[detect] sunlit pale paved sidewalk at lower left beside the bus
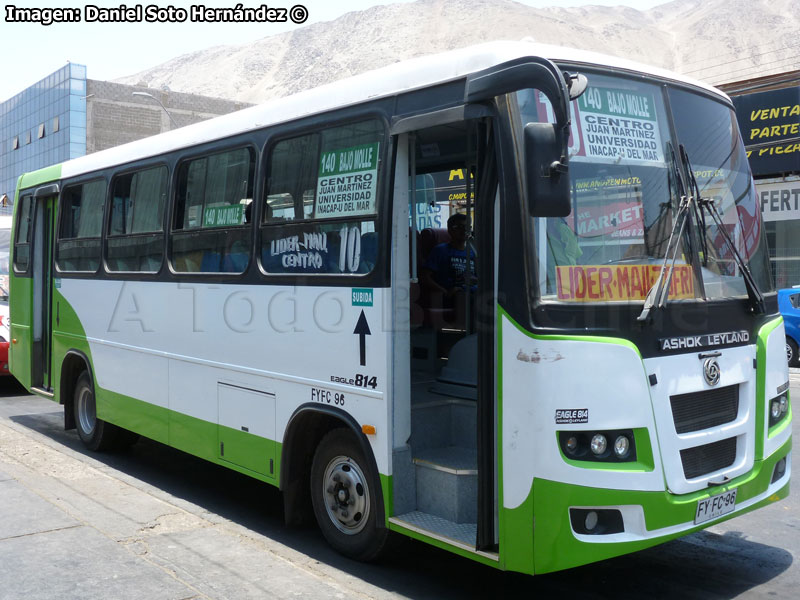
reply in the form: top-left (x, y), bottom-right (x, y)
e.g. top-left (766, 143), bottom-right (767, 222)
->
top-left (0, 397), bottom-right (396, 600)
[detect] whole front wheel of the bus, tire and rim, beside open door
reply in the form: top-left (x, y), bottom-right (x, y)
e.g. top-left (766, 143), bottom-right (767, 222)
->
top-left (311, 429), bottom-right (389, 561)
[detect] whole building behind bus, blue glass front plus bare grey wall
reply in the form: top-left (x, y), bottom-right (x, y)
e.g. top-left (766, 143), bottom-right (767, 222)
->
top-left (0, 63), bottom-right (250, 214)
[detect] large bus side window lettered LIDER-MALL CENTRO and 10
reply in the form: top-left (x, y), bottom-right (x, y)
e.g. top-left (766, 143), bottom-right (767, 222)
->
top-left (261, 121), bottom-right (384, 275)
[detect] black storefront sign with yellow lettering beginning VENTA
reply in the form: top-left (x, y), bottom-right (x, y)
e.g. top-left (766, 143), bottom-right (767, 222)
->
top-left (733, 87), bottom-right (800, 176)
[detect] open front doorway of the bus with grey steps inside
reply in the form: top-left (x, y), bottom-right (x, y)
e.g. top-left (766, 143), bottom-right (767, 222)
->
top-left (390, 113), bottom-right (498, 556)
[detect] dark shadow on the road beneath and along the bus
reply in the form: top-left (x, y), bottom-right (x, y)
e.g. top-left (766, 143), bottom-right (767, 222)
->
top-left (6, 411), bottom-right (793, 600)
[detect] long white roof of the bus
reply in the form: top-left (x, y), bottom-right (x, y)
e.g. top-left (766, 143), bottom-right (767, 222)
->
top-left (45, 42), bottom-right (727, 183)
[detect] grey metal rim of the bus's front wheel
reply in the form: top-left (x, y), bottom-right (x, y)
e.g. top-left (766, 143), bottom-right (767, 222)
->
top-left (322, 456), bottom-right (369, 535)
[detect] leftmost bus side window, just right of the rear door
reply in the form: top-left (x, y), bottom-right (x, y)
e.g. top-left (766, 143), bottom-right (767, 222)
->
top-left (56, 181), bottom-right (106, 272)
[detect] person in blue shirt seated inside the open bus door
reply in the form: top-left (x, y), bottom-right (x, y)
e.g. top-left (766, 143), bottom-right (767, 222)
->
top-left (420, 213), bottom-right (477, 298)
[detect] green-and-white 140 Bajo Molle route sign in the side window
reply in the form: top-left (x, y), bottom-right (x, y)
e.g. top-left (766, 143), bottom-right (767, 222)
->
top-left (315, 142), bottom-right (380, 218)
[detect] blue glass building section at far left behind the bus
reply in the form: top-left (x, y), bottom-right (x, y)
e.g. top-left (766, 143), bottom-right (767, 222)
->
top-left (0, 63), bottom-right (86, 214)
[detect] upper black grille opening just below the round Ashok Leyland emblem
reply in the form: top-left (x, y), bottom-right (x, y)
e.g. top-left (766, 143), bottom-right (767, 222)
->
top-left (669, 385), bottom-right (739, 433)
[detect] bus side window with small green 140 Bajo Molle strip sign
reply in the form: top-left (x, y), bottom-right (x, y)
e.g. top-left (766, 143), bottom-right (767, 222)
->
top-left (170, 148), bottom-right (255, 273)
